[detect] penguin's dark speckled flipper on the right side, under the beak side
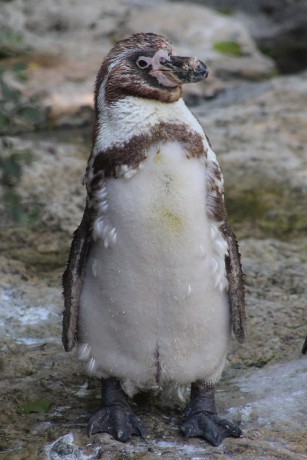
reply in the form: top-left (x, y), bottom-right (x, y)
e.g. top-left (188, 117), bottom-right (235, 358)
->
top-left (221, 220), bottom-right (246, 343)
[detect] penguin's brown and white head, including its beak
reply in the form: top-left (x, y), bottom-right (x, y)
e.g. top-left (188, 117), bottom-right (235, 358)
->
top-left (95, 33), bottom-right (208, 111)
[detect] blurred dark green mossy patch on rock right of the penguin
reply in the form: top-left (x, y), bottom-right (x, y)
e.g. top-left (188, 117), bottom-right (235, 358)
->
top-left (225, 183), bottom-right (307, 240)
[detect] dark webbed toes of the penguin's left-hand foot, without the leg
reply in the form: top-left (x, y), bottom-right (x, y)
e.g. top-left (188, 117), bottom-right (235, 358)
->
top-left (87, 404), bottom-right (144, 442)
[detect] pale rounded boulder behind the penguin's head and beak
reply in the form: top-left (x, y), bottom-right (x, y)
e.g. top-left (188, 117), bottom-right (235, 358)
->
top-left (127, 3), bottom-right (274, 80)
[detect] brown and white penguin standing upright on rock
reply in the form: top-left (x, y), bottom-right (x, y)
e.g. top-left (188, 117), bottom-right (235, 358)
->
top-left (63, 33), bottom-right (246, 446)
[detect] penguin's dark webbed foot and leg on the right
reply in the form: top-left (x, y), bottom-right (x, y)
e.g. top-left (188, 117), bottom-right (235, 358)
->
top-left (181, 380), bottom-right (242, 446)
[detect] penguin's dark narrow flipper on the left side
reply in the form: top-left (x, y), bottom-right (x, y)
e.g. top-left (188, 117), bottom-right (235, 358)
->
top-left (62, 206), bottom-right (91, 351)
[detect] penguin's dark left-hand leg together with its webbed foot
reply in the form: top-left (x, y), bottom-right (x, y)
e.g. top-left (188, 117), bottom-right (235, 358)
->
top-left (87, 378), bottom-right (144, 442)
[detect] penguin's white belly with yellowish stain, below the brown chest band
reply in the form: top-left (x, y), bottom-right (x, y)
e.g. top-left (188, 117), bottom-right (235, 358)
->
top-left (79, 142), bottom-right (230, 393)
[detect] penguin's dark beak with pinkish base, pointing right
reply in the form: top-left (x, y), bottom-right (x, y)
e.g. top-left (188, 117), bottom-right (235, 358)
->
top-left (159, 56), bottom-right (209, 85)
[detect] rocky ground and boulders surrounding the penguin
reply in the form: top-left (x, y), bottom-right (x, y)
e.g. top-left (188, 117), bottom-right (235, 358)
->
top-left (0, 0), bottom-right (307, 460)
